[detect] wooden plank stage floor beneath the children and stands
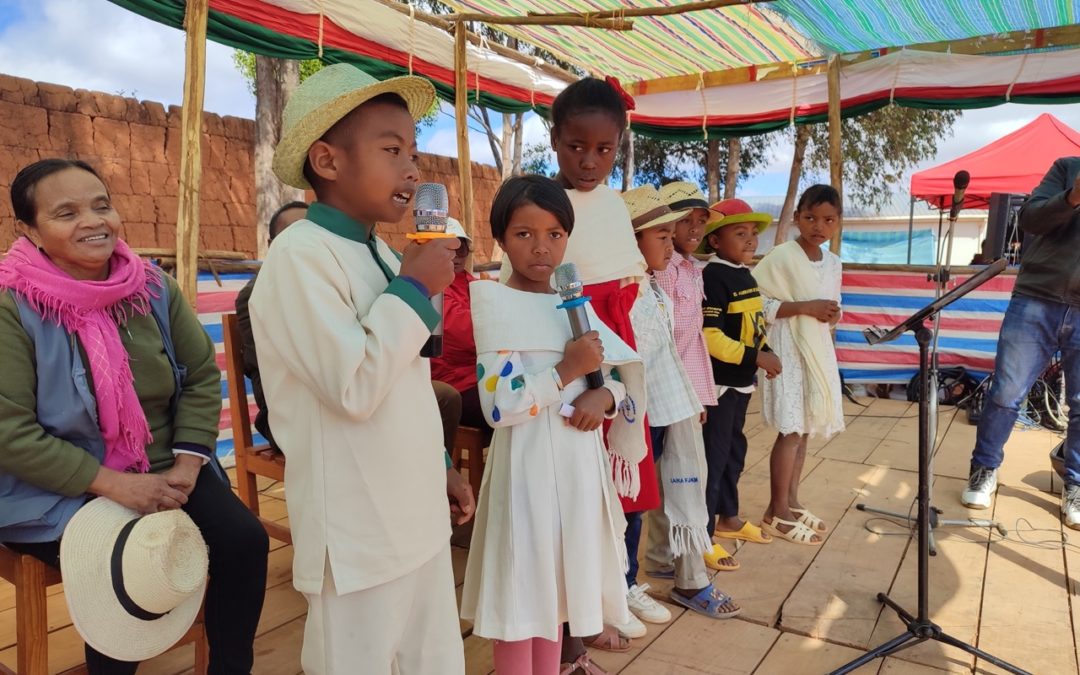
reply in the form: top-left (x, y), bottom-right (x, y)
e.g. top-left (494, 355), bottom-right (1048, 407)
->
top-left (0, 399), bottom-right (1067, 675)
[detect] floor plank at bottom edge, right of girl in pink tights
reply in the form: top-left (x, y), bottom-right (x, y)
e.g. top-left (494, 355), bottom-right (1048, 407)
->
top-left (617, 611), bottom-right (780, 675)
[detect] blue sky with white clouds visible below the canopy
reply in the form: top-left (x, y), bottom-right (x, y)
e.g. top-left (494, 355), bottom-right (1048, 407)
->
top-left (0, 0), bottom-right (1080, 197)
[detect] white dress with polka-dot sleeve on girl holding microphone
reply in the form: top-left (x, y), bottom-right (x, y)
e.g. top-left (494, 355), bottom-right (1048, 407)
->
top-left (461, 282), bottom-right (629, 640)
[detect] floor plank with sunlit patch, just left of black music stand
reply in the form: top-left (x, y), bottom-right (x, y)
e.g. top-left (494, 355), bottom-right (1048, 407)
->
top-left (781, 468), bottom-right (914, 648)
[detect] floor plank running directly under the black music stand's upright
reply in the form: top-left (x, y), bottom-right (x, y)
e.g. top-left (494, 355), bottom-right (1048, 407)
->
top-left (869, 478), bottom-right (989, 672)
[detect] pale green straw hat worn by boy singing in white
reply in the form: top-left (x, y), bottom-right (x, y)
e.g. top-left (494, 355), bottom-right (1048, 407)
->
top-left (273, 64), bottom-right (435, 190)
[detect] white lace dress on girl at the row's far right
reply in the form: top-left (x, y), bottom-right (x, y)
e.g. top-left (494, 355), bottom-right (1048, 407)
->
top-left (758, 251), bottom-right (843, 437)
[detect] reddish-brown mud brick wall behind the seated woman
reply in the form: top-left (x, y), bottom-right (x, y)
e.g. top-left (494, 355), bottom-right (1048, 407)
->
top-left (0, 75), bottom-right (500, 261)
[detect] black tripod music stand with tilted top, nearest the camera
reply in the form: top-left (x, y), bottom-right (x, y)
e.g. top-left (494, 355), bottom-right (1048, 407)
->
top-left (832, 259), bottom-right (1030, 675)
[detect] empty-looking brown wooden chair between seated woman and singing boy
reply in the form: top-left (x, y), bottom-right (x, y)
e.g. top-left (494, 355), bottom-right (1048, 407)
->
top-left (221, 313), bottom-right (293, 543)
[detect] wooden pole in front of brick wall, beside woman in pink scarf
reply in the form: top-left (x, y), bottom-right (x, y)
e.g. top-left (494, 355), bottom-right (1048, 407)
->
top-left (176, 0), bottom-right (210, 308)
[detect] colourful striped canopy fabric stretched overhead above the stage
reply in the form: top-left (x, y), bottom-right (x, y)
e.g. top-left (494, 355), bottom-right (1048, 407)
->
top-left (111, 0), bottom-right (1080, 140)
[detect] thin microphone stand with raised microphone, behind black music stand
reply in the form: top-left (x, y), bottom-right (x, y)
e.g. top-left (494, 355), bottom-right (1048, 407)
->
top-left (855, 193), bottom-right (1008, 555)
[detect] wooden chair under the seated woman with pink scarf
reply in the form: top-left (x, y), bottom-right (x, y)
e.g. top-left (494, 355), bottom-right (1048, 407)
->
top-left (0, 545), bottom-right (210, 675)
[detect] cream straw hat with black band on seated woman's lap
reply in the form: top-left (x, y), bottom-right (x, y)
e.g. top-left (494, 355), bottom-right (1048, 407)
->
top-left (60, 497), bottom-right (208, 661)
